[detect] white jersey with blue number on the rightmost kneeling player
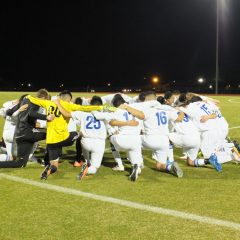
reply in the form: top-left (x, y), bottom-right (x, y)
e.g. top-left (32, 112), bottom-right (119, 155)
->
top-left (180, 101), bottom-right (217, 132)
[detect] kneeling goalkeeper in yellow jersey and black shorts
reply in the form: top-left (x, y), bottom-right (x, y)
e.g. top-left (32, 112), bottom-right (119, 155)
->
top-left (27, 91), bottom-right (103, 180)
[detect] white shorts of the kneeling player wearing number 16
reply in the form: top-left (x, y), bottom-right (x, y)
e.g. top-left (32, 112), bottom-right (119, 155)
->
top-left (142, 135), bottom-right (169, 164)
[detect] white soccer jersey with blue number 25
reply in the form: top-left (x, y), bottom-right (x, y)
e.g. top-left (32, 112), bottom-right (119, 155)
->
top-left (71, 111), bottom-right (107, 139)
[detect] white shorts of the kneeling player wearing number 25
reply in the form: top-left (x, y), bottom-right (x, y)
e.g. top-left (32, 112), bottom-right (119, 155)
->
top-left (81, 137), bottom-right (105, 168)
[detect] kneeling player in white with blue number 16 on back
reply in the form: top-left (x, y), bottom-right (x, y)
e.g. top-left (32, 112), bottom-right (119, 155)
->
top-left (119, 100), bottom-right (183, 177)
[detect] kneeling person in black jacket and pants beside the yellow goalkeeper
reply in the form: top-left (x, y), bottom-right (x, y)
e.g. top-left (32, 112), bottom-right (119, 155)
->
top-left (0, 89), bottom-right (54, 168)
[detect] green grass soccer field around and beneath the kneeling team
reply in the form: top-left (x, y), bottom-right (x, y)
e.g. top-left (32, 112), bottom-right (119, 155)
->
top-left (0, 92), bottom-right (240, 240)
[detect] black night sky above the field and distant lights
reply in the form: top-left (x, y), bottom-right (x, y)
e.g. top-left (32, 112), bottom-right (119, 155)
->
top-left (0, 0), bottom-right (240, 90)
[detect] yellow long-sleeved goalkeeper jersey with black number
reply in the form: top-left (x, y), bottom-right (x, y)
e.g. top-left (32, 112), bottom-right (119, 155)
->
top-left (27, 95), bottom-right (103, 144)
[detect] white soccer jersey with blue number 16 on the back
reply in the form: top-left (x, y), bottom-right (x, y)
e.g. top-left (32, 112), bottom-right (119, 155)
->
top-left (143, 108), bottom-right (178, 135)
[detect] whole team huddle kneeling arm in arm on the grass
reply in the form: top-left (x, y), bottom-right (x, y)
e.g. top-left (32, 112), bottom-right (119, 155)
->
top-left (0, 89), bottom-right (240, 181)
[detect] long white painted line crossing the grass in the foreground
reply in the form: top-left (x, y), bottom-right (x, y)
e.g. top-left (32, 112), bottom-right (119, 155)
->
top-left (0, 173), bottom-right (240, 231)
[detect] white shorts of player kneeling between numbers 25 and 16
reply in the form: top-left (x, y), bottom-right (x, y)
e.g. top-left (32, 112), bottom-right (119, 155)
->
top-left (110, 134), bottom-right (143, 165)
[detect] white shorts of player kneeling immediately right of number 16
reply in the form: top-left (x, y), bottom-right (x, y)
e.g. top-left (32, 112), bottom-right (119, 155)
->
top-left (169, 132), bottom-right (201, 160)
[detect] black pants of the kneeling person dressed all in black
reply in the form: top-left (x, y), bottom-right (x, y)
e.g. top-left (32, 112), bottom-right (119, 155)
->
top-left (0, 132), bottom-right (46, 168)
